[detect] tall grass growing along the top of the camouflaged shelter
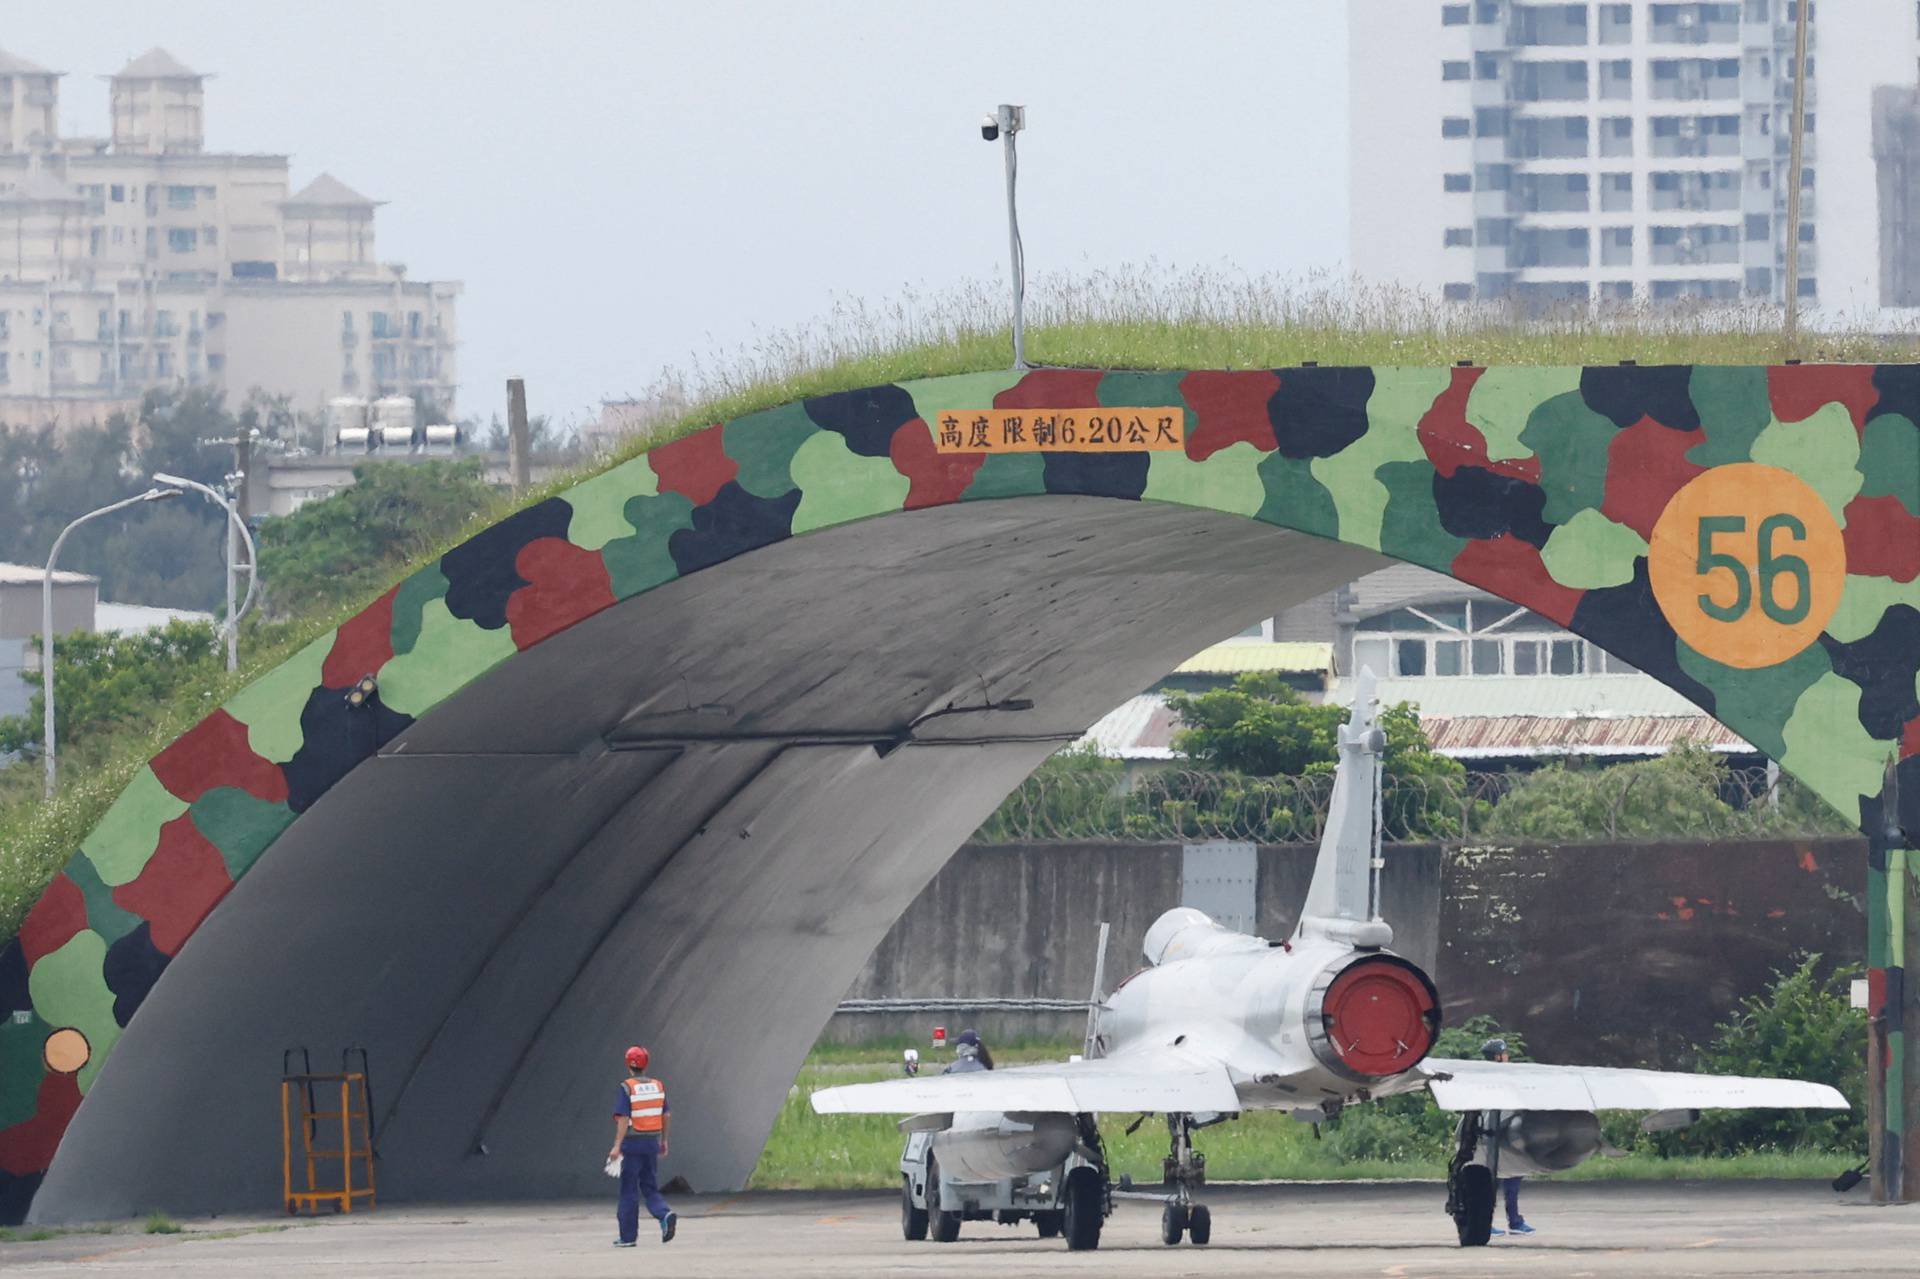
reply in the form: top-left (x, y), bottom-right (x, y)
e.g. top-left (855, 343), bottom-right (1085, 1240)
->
top-left (0, 263), bottom-right (1920, 939)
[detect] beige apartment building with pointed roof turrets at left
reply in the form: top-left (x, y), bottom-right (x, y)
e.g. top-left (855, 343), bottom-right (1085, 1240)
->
top-left (0, 50), bottom-right (461, 424)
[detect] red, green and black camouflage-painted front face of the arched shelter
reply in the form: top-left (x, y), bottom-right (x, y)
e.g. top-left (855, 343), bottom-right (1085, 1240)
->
top-left (0, 365), bottom-right (1920, 1214)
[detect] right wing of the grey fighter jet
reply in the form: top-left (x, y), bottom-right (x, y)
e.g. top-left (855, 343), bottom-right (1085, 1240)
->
top-left (1421, 1056), bottom-right (1847, 1110)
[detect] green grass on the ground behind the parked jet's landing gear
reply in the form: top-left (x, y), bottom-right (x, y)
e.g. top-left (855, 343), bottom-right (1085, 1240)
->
top-left (749, 1043), bottom-right (1859, 1191)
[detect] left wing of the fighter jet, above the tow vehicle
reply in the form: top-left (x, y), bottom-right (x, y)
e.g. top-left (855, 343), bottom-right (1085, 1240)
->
top-left (812, 1050), bottom-right (1240, 1114)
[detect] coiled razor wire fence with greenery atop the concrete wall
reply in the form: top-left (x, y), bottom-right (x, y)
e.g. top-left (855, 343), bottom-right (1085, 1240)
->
top-left (973, 753), bottom-right (1859, 843)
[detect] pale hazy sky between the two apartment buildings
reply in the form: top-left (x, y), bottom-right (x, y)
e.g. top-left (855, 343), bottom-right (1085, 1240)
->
top-left (22, 0), bottom-right (1346, 428)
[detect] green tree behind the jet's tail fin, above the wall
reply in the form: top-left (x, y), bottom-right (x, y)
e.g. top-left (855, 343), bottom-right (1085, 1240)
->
top-left (1167, 674), bottom-right (1467, 839)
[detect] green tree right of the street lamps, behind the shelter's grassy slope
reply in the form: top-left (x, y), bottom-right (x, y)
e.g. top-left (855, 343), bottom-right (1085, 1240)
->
top-left (257, 459), bottom-right (493, 616)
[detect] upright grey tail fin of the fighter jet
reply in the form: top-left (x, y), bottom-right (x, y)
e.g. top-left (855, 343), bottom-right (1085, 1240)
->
top-left (1296, 668), bottom-right (1394, 947)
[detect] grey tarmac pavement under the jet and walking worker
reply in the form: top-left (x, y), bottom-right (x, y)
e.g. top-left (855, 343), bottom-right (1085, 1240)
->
top-left (0, 1181), bottom-right (1920, 1279)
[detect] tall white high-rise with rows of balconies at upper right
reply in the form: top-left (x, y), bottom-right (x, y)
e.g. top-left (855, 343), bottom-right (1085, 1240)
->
top-left (1348, 0), bottom-right (1920, 311)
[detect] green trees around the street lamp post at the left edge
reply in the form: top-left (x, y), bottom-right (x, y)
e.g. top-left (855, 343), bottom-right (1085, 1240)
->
top-left (0, 622), bottom-right (225, 759)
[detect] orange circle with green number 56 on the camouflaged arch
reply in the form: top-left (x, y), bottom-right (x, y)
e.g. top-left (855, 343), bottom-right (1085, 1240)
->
top-left (1647, 463), bottom-right (1847, 670)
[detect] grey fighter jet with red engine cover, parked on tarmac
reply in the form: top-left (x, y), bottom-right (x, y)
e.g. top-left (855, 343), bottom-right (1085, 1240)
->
top-left (812, 672), bottom-right (1847, 1248)
